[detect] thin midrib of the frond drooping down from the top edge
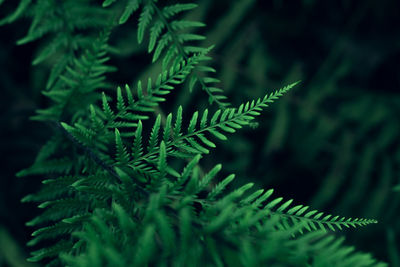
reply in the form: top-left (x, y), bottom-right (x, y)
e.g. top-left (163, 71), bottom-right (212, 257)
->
top-left (150, 1), bottom-right (226, 109)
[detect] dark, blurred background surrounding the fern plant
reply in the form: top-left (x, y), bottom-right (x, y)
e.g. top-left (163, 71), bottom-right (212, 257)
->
top-left (0, 0), bottom-right (400, 266)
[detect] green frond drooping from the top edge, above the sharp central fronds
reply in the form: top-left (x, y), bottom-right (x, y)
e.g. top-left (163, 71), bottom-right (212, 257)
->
top-left (103, 0), bottom-right (229, 108)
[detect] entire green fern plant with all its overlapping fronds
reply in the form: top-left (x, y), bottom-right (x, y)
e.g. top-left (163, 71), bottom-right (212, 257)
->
top-left (0, 0), bottom-right (384, 266)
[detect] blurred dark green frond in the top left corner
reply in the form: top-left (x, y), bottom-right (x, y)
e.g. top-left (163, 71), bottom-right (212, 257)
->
top-left (0, 0), bottom-right (111, 90)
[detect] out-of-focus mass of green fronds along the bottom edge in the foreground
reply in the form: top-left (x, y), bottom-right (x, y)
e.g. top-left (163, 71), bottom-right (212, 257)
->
top-left (57, 172), bottom-right (386, 267)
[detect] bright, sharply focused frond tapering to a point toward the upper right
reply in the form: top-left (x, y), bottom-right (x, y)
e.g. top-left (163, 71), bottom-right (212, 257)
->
top-left (129, 83), bottom-right (297, 171)
